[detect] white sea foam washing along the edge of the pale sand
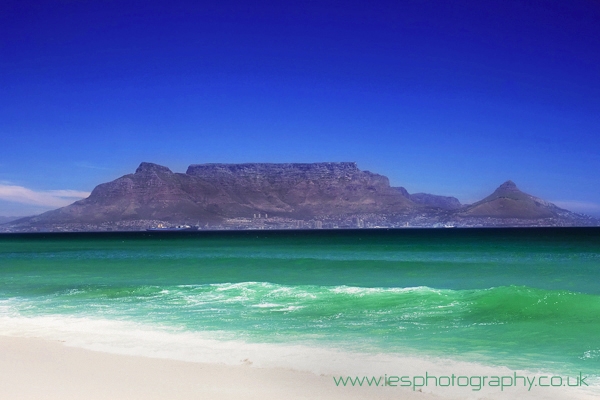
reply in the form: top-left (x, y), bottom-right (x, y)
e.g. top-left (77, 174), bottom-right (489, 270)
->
top-left (0, 314), bottom-right (600, 399)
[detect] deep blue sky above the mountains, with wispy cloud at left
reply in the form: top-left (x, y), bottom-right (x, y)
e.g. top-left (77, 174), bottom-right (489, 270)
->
top-left (0, 0), bottom-right (600, 215)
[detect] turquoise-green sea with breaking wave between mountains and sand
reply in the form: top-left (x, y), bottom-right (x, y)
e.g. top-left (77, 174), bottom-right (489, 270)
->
top-left (0, 228), bottom-right (600, 375)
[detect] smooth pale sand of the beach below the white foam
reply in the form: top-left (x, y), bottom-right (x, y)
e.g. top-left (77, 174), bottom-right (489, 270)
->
top-left (0, 336), bottom-right (597, 400)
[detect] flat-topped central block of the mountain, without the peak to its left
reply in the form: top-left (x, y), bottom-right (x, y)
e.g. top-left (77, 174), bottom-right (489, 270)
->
top-left (186, 163), bottom-right (414, 218)
